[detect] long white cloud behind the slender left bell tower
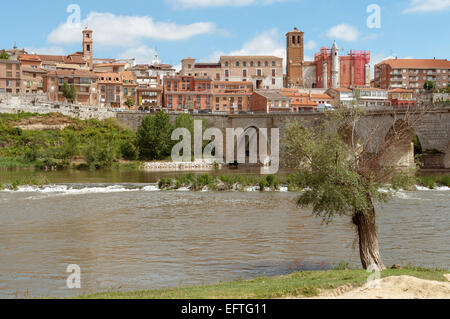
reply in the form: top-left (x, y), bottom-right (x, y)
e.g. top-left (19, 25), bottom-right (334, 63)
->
top-left (48, 12), bottom-right (217, 47)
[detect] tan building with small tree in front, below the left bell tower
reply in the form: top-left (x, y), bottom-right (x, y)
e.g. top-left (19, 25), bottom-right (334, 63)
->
top-left (43, 70), bottom-right (98, 105)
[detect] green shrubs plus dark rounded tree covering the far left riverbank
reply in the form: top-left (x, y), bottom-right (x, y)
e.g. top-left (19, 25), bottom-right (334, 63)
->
top-left (0, 112), bottom-right (206, 171)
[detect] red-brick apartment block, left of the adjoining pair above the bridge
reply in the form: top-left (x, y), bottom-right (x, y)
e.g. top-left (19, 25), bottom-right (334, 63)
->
top-left (163, 76), bottom-right (213, 111)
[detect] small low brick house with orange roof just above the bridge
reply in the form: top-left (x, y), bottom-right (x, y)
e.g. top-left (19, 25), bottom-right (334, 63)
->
top-left (250, 90), bottom-right (291, 113)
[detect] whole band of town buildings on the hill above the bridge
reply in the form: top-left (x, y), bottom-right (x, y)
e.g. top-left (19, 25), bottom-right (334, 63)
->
top-left (0, 28), bottom-right (450, 114)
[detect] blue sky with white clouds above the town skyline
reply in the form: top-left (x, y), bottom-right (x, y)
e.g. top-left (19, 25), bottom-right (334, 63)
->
top-left (0, 0), bottom-right (450, 77)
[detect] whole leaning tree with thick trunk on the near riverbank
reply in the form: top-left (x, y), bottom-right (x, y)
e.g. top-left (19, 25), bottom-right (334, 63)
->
top-left (284, 109), bottom-right (426, 270)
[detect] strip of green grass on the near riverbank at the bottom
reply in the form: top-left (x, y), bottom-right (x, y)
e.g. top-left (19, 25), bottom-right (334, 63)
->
top-left (79, 267), bottom-right (449, 299)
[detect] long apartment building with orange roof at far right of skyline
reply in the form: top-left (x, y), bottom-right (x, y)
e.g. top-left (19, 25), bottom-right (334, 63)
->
top-left (374, 59), bottom-right (450, 94)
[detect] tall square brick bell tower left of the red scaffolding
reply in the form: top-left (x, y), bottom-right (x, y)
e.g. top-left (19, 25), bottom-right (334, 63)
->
top-left (286, 28), bottom-right (304, 88)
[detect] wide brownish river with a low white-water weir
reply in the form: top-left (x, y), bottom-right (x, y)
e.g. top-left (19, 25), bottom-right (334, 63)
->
top-left (0, 171), bottom-right (450, 298)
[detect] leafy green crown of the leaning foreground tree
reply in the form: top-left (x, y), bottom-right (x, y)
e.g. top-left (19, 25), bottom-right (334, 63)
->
top-left (285, 122), bottom-right (372, 221)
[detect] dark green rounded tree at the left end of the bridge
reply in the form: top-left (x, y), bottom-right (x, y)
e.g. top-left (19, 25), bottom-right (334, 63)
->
top-left (136, 111), bottom-right (174, 160)
